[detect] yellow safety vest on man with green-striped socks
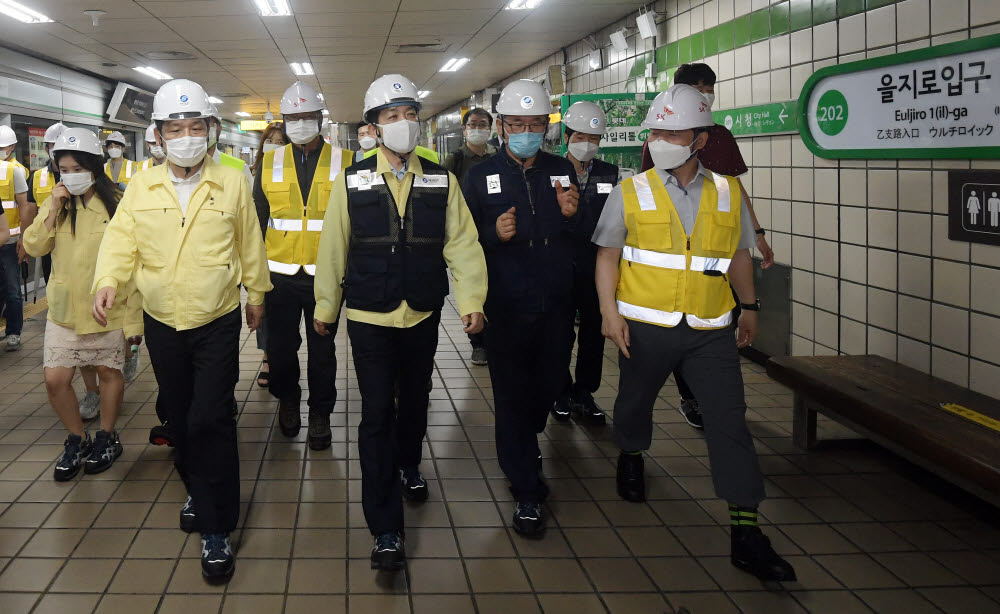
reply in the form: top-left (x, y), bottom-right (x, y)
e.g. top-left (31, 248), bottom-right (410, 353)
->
top-left (617, 169), bottom-right (742, 329)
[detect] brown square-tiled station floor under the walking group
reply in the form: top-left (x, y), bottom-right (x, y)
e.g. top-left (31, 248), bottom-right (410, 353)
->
top-left (0, 296), bottom-right (1000, 614)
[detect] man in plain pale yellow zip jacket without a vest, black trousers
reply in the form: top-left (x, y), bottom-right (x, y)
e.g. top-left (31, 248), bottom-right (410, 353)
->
top-left (94, 79), bottom-right (271, 579)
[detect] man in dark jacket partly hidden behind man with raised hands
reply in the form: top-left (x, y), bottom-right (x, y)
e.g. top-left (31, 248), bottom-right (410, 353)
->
top-left (552, 101), bottom-right (618, 426)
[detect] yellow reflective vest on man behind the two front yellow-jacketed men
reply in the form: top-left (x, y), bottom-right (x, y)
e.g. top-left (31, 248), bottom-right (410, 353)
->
top-left (260, 143), bottom-right (354, 275)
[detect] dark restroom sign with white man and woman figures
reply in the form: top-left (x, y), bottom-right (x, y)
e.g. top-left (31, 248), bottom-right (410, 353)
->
top-left (948, 170), bottom-right (1000, 245)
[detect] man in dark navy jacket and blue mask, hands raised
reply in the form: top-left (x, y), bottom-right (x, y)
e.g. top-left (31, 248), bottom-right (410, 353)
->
top-left (463, 80), bottom-right (579, 536)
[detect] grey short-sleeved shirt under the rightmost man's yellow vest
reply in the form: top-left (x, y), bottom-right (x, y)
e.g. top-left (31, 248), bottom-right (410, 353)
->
top-left (592, 164), bottom-right (757, 249)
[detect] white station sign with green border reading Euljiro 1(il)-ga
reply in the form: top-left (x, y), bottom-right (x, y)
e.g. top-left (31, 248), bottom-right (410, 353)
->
top-left (798, 34), bottom-right (1000, 159)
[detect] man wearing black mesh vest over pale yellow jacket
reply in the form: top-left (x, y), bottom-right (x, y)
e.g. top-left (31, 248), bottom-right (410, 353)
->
top-left (314, 75), bottom-right (486, 570)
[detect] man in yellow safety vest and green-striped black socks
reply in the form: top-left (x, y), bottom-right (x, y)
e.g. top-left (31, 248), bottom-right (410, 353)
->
top-left (593, 84), bottom-right (795, 582)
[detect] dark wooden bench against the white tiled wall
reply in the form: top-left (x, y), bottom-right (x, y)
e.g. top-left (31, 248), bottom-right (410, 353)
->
top-left (767, 356), bottom-right (1000, 506)
